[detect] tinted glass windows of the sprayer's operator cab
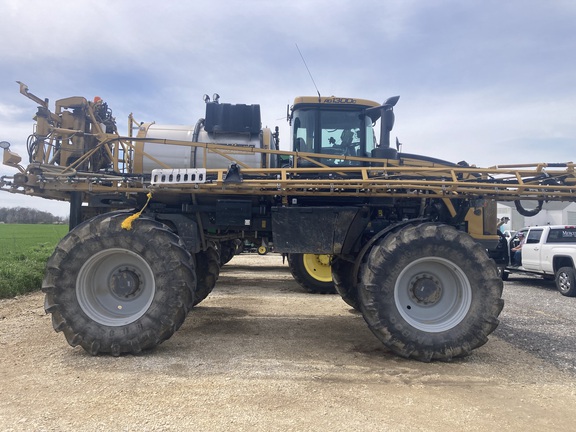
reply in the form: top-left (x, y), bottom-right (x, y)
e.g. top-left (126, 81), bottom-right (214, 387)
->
top-left (292, 108), bottom-right (375, 165)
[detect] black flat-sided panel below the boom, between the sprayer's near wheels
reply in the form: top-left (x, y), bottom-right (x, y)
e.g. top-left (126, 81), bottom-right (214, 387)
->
top-left (272, 207), bottom-right (360, 254)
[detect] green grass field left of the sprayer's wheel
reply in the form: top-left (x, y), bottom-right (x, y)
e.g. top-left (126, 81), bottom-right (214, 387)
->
top-left (0, 224), bottom-right (68, 298)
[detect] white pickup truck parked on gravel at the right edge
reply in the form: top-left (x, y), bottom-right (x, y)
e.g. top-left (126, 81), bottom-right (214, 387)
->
top-left (502, 225), bottom-right (576, 297)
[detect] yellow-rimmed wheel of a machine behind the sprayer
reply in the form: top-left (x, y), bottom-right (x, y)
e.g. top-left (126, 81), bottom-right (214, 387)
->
top-left (288, 254), bottom-right (336, 294)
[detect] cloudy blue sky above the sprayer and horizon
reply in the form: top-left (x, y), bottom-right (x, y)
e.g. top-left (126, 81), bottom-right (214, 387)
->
top-left (0, 0), bottom-right (576, 215)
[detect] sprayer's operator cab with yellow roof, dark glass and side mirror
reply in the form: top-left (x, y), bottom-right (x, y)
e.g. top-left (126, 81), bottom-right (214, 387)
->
top-left (288, 96), bottom-right (399, 166)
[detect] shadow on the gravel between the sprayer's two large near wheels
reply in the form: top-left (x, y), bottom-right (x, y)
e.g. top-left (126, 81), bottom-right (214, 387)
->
top-left (164, 300), bottom-right (397, 370)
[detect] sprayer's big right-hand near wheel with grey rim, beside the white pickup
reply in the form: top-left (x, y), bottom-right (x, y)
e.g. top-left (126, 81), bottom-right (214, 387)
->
top-left (358, 223), bottom-right (504, 361)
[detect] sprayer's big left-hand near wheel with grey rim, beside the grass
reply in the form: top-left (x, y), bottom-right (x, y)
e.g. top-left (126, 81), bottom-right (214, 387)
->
top-left (42, 214), bottom-right (196, 356)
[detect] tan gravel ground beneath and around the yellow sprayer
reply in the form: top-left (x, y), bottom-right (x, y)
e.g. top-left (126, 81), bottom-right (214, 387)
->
top-left (0, 255), bottom-right (576, 431)
